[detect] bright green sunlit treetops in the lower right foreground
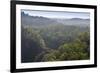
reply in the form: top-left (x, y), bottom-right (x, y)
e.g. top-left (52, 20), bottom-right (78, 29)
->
top-left (44, 32), bottom-right (89, 61)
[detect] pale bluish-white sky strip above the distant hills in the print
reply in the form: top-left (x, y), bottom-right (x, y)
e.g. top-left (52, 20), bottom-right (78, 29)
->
top-left (21, 9), bottom-right (90, 19)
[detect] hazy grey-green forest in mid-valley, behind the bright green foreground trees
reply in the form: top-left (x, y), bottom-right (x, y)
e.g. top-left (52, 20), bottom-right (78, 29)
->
top-left (40, 25), bottom-right (89, 49)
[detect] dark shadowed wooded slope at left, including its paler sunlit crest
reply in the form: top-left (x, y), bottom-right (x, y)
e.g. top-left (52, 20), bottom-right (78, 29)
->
top-left (21, 26), bottom-right (48, 62)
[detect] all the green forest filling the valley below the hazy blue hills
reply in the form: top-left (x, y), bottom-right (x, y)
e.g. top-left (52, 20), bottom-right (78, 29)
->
top-left (21, 12), bottom-right (90, 62)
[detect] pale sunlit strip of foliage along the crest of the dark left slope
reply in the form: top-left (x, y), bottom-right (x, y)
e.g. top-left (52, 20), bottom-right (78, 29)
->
top-left (25, 27), bottom-right (47, 49)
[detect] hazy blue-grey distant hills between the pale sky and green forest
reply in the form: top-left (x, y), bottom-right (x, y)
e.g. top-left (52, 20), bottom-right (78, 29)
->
top-left (21, 12), bottom-right (90, 27)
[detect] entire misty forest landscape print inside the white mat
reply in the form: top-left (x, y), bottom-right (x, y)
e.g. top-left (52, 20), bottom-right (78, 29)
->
top-left (21, 10), bottom-right (90, 63)
